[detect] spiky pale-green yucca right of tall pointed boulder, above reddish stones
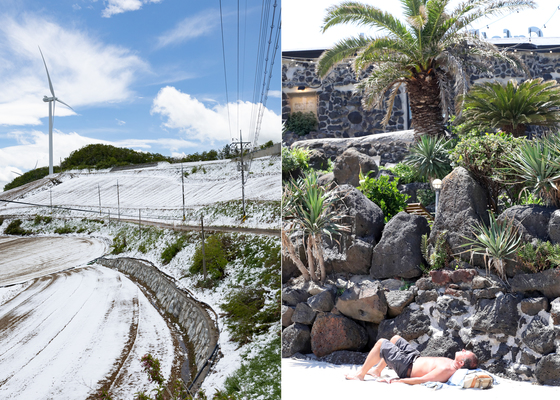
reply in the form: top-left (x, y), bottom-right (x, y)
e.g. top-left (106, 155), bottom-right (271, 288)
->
top-left (462, 213), bottom-right (521, 280)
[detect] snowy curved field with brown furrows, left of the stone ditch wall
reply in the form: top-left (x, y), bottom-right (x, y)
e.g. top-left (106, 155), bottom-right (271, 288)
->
top-left (0, 238), bottom-right (179, 399)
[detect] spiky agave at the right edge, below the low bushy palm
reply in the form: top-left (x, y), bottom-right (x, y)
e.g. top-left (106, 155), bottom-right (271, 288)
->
top-left (500, 135), bottom-right (560, 206)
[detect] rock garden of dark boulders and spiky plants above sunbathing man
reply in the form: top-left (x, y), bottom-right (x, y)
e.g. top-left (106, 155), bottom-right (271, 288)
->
top-left (282, 127), bottom-right (560, 386)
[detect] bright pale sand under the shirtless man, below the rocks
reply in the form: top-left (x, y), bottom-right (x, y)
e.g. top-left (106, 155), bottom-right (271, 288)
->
top-left (282, 358), bottom-right (560, 400)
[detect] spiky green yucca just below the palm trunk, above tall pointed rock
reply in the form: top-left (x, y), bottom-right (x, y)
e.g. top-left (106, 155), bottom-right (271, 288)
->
top-left (404, 135), bottom-right (451, 182)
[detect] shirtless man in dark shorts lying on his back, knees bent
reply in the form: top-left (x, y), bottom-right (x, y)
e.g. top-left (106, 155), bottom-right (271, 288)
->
top-left (346, 335), bottom-right (478, 385)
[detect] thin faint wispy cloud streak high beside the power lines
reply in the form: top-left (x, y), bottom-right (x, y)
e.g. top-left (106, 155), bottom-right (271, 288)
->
top-left (157, 10), bottom-right (219, 48)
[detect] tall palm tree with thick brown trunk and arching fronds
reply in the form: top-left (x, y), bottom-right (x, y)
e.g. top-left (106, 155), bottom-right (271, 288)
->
top-left (317, 0), bottom-right (535, 137)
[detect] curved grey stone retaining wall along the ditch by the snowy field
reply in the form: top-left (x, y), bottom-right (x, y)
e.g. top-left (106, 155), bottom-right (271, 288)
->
top-left (97, 258), bottom-right (219, 379)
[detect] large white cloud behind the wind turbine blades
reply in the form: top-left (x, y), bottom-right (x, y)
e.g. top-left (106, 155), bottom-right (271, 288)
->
top-left (0, 15), bottom-right (147, 125)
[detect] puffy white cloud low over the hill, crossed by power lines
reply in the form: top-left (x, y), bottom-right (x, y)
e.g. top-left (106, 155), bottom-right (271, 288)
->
top-left (151, 86), bottom-right (281, 143)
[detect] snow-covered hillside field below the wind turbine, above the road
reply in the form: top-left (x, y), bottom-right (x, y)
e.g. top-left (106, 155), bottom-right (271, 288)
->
top-left (0, 157), bottom-right (282, 229)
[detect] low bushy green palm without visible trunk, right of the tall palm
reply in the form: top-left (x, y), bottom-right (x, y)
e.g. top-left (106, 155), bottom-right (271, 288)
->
top-left (462, 78), bottom-right (560, 137)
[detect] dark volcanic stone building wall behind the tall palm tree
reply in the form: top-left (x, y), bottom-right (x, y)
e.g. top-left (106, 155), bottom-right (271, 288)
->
top-left (282, 51), bottom-right (560, 145)
